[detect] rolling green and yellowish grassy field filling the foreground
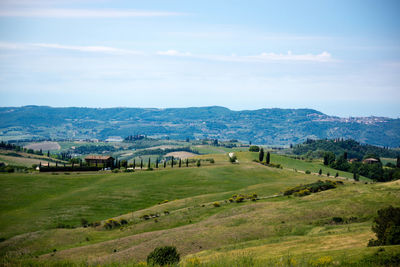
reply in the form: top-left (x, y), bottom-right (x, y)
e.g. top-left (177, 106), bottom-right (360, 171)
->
top-left (0, 152), bottom-right (400, 266)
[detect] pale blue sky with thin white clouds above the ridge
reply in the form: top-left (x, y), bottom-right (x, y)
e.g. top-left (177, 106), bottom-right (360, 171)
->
top-left (0, 0), bottom-right (400, 118)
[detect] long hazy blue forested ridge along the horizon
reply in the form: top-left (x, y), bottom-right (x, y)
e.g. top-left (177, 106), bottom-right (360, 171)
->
top-left (0, 106), bottom-right (400, 147)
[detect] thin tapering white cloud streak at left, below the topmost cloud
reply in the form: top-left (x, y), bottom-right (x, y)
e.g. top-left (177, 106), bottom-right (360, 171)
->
top-left (32, 43), bottom-right (142, 55)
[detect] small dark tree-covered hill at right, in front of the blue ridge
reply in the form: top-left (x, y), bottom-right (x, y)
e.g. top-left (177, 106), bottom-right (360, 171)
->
top-left (293, 139), bottom-right (400, 159)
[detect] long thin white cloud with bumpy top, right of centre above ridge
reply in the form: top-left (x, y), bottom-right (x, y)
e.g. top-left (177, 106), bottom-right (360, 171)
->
top-left (157, 50), bottom-right (334, 62)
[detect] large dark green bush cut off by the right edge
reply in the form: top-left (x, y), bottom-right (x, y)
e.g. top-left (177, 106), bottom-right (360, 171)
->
top-left (368, 206), bottom-right (400, 246)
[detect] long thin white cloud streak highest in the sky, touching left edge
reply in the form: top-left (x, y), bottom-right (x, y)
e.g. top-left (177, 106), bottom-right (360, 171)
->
top-left (0, 8), bottom-right (182, 18)
